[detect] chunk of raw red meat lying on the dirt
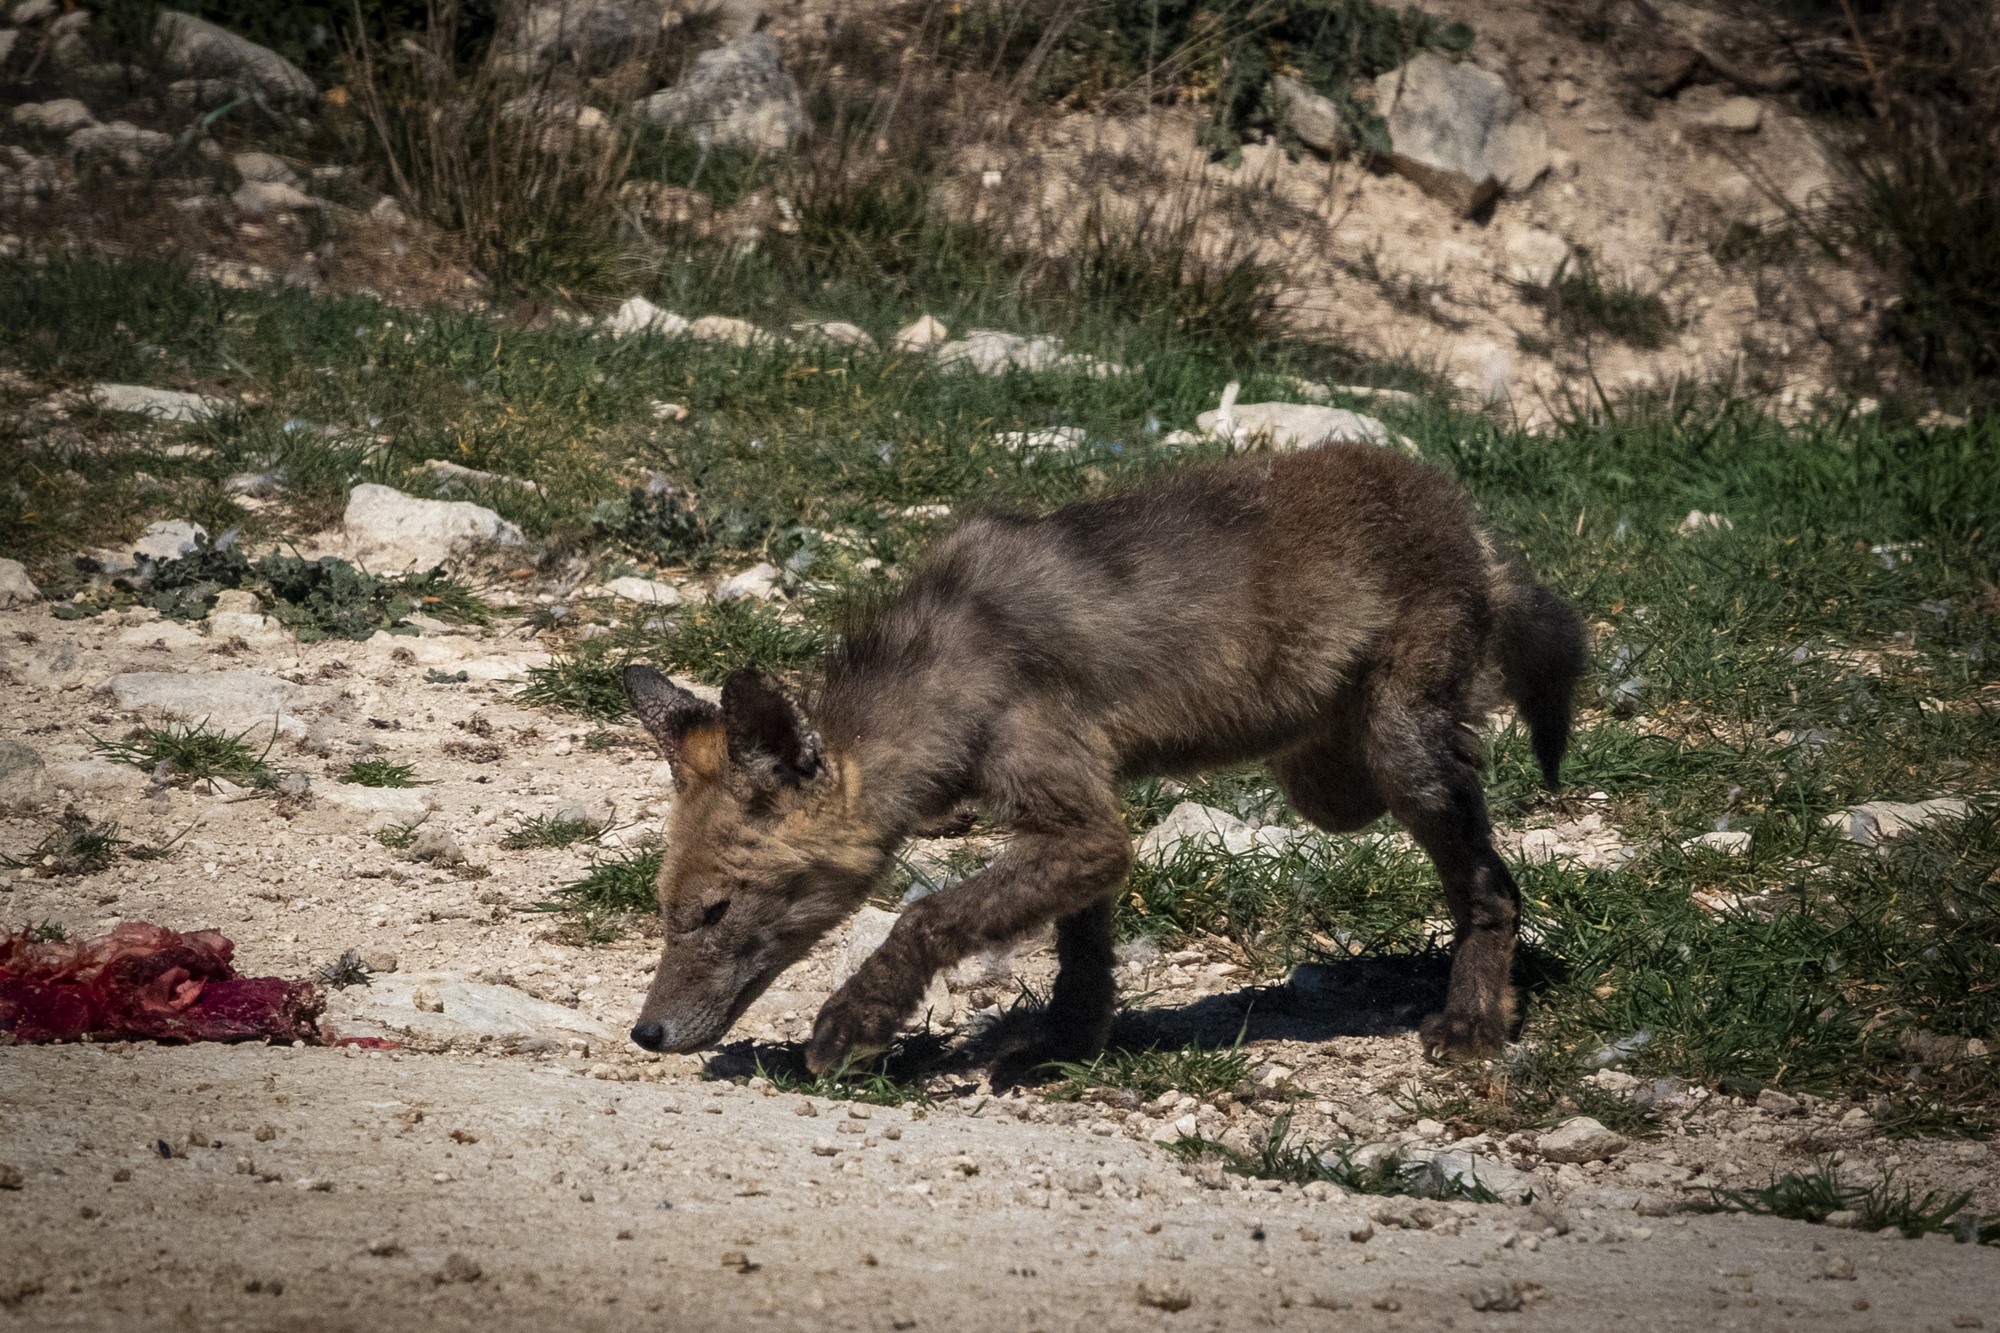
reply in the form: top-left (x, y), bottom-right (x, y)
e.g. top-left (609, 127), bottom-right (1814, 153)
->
top-left (0, 921), bottom-right (324, 1045)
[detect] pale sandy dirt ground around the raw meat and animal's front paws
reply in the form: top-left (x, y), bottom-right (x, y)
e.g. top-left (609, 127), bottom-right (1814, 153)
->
top-left (0, 608), bottom-right (2000, 1329)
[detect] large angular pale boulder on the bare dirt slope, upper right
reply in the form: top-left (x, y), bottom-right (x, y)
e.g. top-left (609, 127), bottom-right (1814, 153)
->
top-left (1374, 52), bottom-right (1548, 216)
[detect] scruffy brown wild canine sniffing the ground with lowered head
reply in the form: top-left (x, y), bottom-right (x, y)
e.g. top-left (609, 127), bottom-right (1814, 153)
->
top-left (626, 446), bottom-right (1584, 1071)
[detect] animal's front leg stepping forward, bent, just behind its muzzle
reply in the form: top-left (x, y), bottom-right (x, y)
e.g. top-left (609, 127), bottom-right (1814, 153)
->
top-left (806, 819), bottom-right (1132, 1073)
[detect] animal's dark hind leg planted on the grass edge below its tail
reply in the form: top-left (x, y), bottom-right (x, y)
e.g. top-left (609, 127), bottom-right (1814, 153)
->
top-left (1368, 697), bottom-right (1520, 1059)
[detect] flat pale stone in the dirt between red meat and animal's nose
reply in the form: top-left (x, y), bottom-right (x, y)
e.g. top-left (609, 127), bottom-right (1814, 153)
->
top-left (326, 973), bottom-right (616, 1049)
